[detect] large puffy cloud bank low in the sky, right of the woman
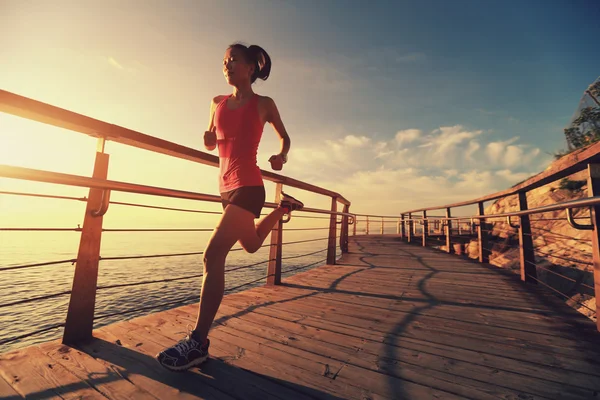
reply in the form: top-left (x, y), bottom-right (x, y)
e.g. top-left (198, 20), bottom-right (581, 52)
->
top-left (286, 125), bottom-right (548, 214)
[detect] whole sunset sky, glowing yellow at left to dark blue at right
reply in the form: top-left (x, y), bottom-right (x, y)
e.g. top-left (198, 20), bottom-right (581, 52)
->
top-left (0, 0), bottom-right (600, 226)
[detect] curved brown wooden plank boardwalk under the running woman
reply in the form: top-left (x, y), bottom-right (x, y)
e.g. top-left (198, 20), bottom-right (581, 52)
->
top-left (0, 236), bottom-right (600, 400)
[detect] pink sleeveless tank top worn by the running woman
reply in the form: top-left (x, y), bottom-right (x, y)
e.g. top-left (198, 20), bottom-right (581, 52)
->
top-left (214, 94), bottom-right (264, 193)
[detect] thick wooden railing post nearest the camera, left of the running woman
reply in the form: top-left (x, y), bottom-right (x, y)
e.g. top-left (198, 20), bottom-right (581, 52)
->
top-left (62, 138), bottom-right (109, 345)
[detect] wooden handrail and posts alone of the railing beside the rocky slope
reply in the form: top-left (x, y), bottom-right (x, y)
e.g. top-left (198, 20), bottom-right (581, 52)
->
top-left (394, 143), bottom-right (600, 330)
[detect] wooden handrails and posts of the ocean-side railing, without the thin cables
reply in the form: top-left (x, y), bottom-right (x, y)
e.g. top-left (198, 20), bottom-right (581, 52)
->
top-left (0, 91), bottom-right (354, 344)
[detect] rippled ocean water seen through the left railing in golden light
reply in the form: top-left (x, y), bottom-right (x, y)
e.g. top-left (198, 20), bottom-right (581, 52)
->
top-left (0, 228), bottom-right (341, 353)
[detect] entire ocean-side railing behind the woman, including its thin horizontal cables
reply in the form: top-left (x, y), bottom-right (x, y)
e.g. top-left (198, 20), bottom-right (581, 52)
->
top-left (0, 90), bottom-right (355, 352)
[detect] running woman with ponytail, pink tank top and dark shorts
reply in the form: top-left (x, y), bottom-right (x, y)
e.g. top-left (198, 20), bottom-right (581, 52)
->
top-left (156, 44), bottom-right (304, 371)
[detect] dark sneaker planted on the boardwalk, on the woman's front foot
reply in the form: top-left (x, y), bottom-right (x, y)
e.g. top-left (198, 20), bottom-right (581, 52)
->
top-left (156, 331), bottom-right (210, 371)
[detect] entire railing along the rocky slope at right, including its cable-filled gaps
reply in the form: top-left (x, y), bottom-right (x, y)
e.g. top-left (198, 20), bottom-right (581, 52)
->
top-left (386, 143), bottom-right (600, 330)
